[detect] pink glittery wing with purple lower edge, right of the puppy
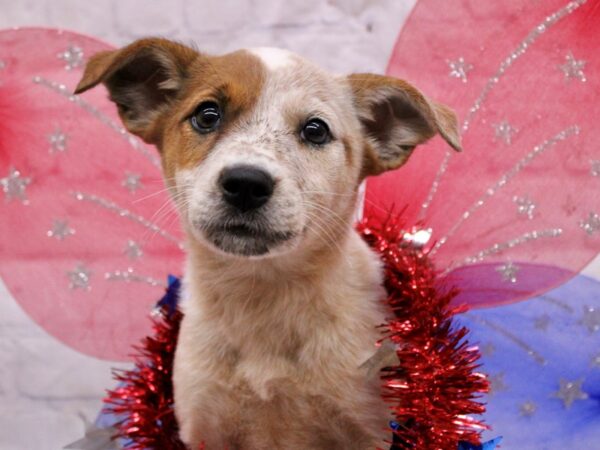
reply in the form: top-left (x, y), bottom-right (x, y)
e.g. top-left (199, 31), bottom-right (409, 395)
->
top-left (365, 0), bottom-right (600, 306)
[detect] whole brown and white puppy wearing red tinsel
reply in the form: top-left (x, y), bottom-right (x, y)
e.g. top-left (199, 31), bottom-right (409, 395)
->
top-left (77, 39), bottom-right (460, 450)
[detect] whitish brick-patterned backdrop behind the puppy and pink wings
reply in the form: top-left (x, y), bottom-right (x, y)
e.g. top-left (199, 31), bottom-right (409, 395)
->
top-left (0, 0), bottom-right (600, 450)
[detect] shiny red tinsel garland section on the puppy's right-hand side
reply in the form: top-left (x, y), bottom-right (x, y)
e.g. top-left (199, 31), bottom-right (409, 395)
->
top-left (358, 219), bottom-right (489, 450)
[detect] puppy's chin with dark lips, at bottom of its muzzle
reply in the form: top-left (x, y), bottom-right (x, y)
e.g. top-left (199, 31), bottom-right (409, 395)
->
top-left (194, 224), bottom-right (298, 259)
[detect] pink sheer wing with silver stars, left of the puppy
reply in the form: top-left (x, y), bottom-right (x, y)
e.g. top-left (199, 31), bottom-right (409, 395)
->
top-left (0, 29), bottom-right (182, 360)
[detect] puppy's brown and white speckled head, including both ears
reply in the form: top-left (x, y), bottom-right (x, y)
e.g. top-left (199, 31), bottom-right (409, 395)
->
top-left (77, 39), bottom-right (460, 257)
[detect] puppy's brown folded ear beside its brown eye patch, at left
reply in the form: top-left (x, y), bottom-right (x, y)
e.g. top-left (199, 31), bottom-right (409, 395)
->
top-left (75, 38), bottom-right (199, 143)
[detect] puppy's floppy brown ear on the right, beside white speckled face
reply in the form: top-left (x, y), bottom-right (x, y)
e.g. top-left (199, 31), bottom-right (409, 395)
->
top-left (348, 74), bottom-right (462, 175)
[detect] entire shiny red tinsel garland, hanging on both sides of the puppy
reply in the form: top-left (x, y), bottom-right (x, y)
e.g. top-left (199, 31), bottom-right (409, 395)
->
top-left (105, 215), bottom-right (488, 450)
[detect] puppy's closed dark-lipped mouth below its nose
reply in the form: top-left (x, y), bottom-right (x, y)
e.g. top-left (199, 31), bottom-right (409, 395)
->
top-left (200, 221), bottom-right (296, 257)
